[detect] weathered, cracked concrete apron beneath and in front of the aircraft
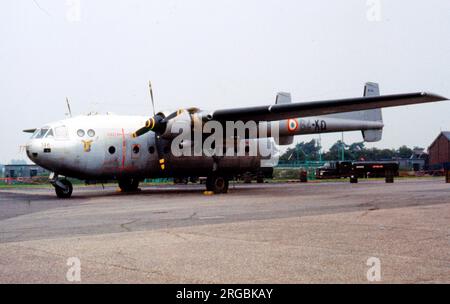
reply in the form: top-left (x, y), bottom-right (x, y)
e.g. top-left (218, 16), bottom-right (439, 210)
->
top-left (0, 179), bottom-right (450, 283)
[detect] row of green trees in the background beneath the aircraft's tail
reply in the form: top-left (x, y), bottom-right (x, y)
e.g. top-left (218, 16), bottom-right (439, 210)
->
top-left (280, 139), bottom-right (417, 161)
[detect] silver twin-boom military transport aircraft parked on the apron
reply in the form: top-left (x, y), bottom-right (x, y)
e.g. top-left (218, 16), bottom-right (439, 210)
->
top-left (24, 82), bottom-right (447, 198)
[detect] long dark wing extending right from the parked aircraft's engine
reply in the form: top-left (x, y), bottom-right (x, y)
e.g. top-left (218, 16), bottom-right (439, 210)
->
top-left (208, 92), bottom-right (447, 121)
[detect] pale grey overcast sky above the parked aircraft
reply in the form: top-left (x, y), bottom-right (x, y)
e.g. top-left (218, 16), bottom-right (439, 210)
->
top-left (0, 0), bottom-right (450, 163)
